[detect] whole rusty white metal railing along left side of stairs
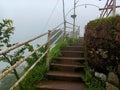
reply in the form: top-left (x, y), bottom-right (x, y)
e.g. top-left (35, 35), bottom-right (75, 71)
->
top-left (0, 22), bottom-right (80, 90)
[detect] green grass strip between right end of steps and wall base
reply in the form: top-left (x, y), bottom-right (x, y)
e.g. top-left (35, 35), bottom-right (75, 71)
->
top-left (83, 50), bottom-right (106, 90)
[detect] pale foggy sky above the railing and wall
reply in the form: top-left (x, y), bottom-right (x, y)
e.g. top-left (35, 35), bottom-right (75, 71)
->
top-left (0, 0), bottom-right (120, 42)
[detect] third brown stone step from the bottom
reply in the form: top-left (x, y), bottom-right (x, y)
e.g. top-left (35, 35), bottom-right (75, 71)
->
top-left (50, 63), bottom-right (84, 72)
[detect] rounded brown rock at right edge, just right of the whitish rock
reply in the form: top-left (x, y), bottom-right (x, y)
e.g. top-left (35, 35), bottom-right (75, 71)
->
top-left (108, 72), bottom-right (119, 85)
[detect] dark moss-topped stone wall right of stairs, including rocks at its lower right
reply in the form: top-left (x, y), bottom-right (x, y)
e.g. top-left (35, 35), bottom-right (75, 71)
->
top-left (84, 16), bottom-right (120, 90)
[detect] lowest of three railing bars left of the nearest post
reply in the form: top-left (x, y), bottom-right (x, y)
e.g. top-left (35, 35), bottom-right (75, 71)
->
top-left (10, 50), bottom-right (48, 90)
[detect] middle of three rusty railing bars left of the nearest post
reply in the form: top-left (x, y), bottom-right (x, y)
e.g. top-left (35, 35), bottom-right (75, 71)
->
top-left (0, 42), bottom-right (48, 79)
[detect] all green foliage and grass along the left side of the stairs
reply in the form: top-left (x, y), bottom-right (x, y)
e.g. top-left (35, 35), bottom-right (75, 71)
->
top-left (19, 41), bottom-right (67, 90)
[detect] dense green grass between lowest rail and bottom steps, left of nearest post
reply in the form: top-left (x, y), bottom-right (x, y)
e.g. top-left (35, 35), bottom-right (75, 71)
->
top-left (22, 60), bottom-right (46, 90)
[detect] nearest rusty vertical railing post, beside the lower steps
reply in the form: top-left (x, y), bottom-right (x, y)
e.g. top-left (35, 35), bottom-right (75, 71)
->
top-left (46, 30), bottom-right (51, 70)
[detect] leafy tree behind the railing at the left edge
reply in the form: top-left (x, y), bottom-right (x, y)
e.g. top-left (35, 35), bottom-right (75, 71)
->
top-left (0, 19), bottom-right (25, 89)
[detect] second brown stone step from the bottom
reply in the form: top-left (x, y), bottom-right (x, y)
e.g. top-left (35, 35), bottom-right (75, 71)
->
top-left (47, 71), bottom-right (84, 82)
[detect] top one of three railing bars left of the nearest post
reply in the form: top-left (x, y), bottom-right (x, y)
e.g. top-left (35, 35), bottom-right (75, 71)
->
top-left (0, 32), bottom-right (48, 55)
